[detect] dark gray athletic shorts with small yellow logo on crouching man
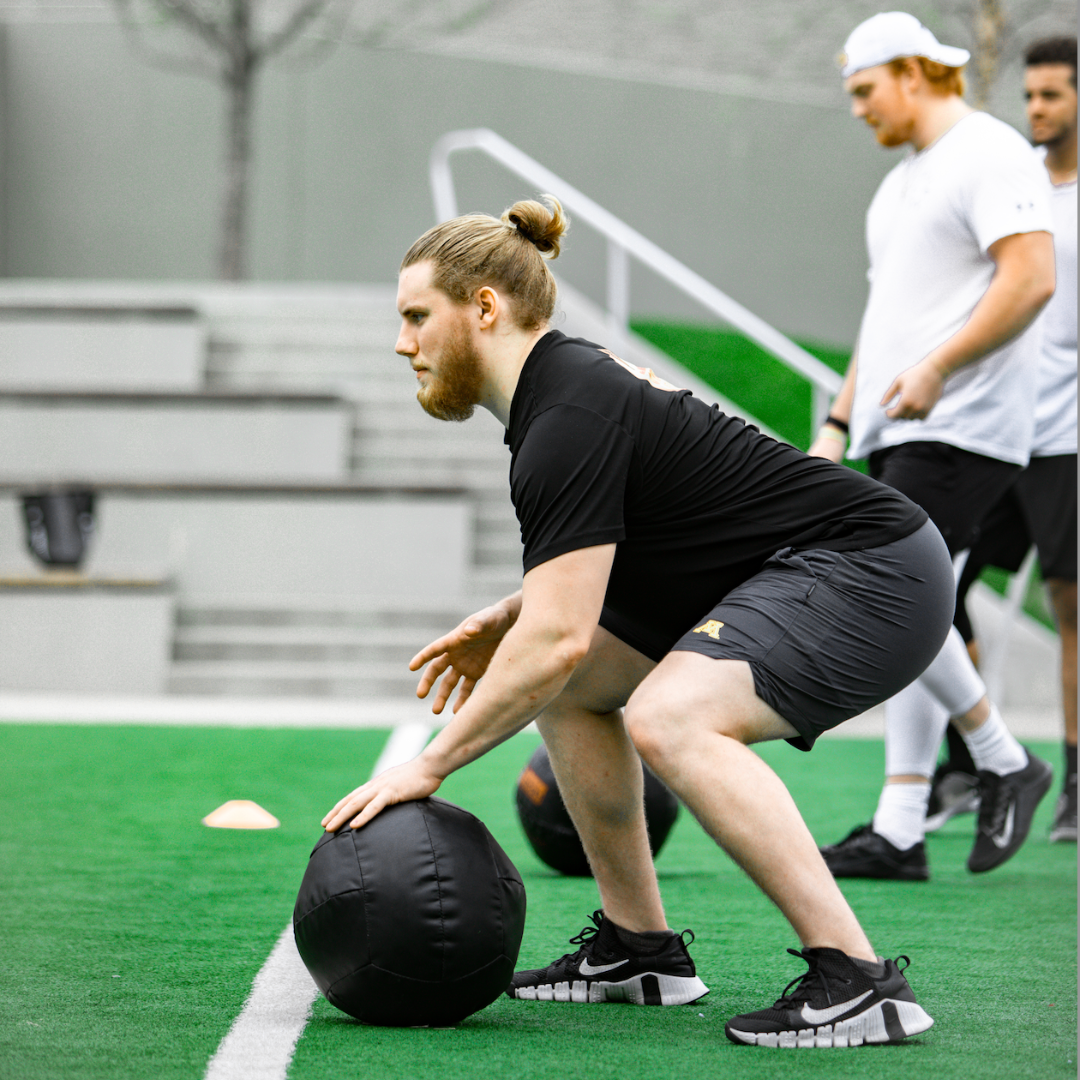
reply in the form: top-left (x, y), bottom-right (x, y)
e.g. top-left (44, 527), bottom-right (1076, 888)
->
top-left (673, 522), bottom-right (955, 750)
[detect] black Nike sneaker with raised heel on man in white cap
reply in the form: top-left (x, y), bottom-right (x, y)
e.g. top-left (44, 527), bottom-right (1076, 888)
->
top-left (968, 751), bottom-right (1054, 874)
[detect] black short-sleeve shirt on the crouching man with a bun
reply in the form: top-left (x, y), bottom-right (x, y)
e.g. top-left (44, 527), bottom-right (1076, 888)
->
top-left (505, 330), bottom-right (928, 659)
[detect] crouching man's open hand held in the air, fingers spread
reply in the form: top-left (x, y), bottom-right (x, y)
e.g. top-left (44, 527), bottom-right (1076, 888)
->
top-left (408, 594), bottom-right (521, 715)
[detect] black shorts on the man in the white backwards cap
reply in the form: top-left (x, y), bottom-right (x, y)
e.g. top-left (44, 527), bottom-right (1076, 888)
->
top-left (869, 443), bottom-right (1021, 555)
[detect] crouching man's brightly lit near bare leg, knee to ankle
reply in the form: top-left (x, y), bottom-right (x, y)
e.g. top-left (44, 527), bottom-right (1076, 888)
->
top-left (626, 652), bottom-right (877, 960)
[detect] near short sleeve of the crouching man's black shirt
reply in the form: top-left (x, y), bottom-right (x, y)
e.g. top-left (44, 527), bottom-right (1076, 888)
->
top-left (510, 405), bottom-right (633, 573)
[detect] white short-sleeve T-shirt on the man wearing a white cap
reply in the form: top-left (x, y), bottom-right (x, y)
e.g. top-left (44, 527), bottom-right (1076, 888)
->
top-left (849, 112), bottom-right (1053, 464)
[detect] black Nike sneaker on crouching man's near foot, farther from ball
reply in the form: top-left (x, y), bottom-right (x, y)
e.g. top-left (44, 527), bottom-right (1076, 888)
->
top-left (724, 948), bottom-right (934, 1049)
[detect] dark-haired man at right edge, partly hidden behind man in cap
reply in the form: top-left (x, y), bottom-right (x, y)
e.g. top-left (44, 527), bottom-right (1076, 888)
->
top-left (927, 37), bottom-right (1077, 843)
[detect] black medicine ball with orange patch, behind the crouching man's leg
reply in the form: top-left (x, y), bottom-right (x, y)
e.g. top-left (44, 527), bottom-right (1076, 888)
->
top-left (516, 743), bottom-right (678, 877)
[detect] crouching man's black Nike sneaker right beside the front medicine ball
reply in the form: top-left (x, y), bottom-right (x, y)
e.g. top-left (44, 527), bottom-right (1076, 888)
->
top-left (507, 912), bottom-right (708, 1005)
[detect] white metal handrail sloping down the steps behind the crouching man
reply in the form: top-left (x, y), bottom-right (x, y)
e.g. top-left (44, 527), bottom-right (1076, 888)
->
top-left (429, 127), bottom-right (842, 430)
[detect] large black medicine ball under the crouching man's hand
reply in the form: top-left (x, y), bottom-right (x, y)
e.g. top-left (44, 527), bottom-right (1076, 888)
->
top-left (293, 798), bottom-right (525, 1027)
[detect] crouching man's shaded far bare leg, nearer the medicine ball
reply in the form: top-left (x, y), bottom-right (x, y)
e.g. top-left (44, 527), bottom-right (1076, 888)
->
top-left (537, 629), bottom-right (667, 932)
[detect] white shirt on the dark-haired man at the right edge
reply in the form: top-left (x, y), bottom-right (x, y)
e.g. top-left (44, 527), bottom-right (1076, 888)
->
top-left (1031, 160), bottom-right (1077, 458)
